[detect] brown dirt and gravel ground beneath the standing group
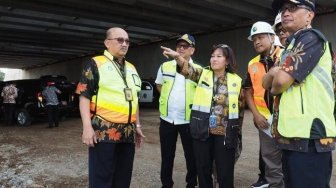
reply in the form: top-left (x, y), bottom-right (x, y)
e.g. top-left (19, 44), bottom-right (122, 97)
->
top-left (0, 109), bottom-right (336, 188)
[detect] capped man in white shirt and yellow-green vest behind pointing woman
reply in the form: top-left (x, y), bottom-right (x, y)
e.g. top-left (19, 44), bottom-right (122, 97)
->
top-left (155, 34), bottom-right (197, 188)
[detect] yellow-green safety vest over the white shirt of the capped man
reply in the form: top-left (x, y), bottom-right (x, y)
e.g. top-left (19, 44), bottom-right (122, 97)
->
top-left (159, 61), bottom-right (200, 121)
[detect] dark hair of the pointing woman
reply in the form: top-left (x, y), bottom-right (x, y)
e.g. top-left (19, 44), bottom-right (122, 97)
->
top-left (211, 44), bottom-right (237, 73)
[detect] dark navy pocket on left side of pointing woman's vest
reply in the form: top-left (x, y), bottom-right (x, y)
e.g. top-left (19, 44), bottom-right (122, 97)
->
top-left (190, 110), bottom-right (210, 141)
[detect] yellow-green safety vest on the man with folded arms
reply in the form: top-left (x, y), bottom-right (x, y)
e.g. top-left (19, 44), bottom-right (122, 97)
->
top-left (278, 35), bottom-right (336, 139)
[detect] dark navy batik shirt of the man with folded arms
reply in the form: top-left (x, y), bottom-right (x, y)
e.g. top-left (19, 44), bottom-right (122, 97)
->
top-left (272, 29), bottom-right (335, 152)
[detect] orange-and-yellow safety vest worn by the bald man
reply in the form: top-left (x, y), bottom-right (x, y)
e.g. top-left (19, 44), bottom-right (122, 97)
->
top-left (91, 51), bottom-right (141, 123)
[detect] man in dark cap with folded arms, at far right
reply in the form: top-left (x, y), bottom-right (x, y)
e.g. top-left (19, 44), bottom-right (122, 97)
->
top-left (268, 0), bottom-right (336, 188)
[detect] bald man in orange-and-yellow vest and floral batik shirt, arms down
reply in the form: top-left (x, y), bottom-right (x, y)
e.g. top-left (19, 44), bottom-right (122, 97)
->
top-left (76, 28), bottom-right (144, 188)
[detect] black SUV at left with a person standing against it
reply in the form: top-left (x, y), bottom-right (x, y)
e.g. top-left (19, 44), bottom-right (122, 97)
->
top-left (6, 76), bottom-right (75, 126)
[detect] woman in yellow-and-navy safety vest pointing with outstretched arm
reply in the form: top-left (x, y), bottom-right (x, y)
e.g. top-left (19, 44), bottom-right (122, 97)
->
top-left (161, 44), bottom-right (244, 188)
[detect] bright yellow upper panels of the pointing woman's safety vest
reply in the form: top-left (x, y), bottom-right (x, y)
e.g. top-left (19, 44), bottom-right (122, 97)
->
top-left (192, 69), bottom-right (241, 119)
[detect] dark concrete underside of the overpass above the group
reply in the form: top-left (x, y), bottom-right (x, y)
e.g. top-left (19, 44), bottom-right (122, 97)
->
top-left (0, 0), bottom-right (336, 81)
